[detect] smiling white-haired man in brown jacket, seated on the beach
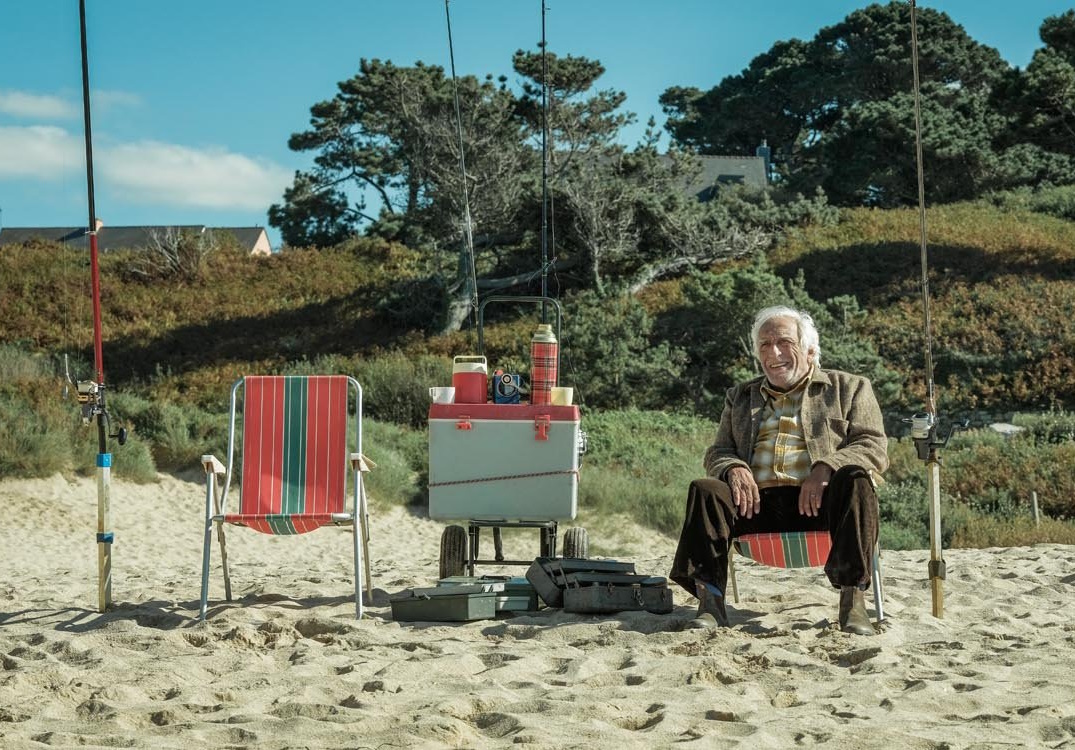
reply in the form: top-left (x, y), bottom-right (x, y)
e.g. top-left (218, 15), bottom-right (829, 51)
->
top-left (670, 307), bottom-right (888, 635)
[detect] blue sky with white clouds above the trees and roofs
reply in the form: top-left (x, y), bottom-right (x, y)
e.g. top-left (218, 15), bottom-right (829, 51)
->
top-left (0, 0), bottom-right (1072, 251)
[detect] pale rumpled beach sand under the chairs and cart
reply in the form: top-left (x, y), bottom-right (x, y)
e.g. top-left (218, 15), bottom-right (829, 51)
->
top-left (0, 476), bottom-right (1075, 750)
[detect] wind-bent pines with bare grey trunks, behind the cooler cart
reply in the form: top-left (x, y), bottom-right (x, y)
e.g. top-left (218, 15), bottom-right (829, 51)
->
top-left (270, 51), bottom-right (825, 329)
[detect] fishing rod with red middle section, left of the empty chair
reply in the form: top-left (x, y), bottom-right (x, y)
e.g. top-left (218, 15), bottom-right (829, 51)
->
top-left (76, 0), bottom-right (127, 612)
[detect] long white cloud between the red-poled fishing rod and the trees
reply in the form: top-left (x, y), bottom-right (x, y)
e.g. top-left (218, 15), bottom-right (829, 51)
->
top-left (100, 141), bottom-right (292, 211)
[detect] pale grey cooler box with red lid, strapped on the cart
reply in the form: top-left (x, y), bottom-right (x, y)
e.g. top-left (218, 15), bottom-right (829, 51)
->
top-left (429, 404), bottom-right (579, 521)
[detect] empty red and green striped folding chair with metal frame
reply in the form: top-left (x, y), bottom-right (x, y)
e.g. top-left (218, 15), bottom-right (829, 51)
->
top-left (199, 375), bottom-right (373, 619)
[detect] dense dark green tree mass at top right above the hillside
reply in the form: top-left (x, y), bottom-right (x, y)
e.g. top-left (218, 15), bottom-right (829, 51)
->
top-left (660, 2), bottom-right (1075, 206)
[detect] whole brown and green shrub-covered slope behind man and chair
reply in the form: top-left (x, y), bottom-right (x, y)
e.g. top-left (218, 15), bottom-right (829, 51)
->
top-left (0, 202), bottom-right (1075, 547)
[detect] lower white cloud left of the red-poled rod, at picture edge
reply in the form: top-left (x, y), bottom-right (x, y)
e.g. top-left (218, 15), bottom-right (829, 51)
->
top-left (0, 125), bottom-right (86, 182)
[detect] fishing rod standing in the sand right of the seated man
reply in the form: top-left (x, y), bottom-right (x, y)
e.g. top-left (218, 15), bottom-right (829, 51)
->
top-left (904, 0), bottom-right (965, 618)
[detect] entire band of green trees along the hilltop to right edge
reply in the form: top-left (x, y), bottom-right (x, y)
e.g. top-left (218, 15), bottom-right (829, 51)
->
top-left (269, 1), bottom-right (1075, 331)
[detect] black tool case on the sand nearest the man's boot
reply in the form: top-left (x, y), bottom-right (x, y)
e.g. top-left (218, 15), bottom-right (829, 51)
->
top-left (563, 572), bottom-right (673, 615)
